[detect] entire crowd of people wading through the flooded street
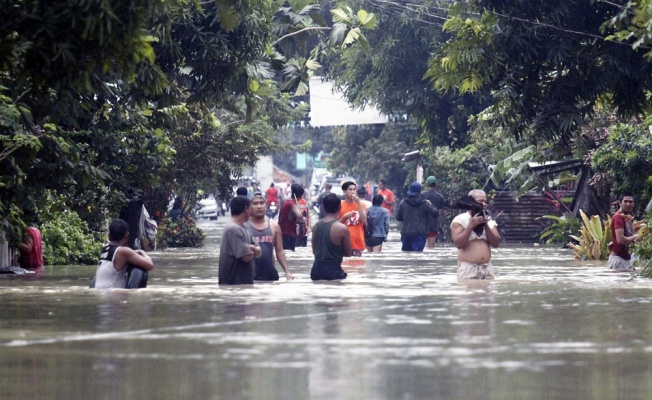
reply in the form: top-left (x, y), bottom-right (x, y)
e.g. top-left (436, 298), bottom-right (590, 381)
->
top-left (65, 180), bottom-right (640, 289)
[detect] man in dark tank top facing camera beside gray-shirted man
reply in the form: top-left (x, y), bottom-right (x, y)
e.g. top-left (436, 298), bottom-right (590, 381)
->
top-left (245, 192), bottom-right (294, 281)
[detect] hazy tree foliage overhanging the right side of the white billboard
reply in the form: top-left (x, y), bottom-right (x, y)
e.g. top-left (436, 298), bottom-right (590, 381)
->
top-left (324, 0), bottom-right (488, 147)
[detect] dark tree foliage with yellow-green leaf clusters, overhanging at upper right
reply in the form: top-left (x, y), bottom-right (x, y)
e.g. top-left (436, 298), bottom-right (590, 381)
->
top-left (427, 0), bottom-right (652, 143)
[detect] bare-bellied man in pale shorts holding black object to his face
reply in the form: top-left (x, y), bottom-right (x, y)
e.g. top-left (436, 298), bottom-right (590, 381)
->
top-left (451, 189), bottom-right (500, 280)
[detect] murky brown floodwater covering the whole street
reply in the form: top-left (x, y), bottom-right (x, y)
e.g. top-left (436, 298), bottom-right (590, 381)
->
top-left (0, 218), bottom-right (652, 400)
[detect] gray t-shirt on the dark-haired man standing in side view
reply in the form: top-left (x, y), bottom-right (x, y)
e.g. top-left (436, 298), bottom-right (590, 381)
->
top-left (218, 221), bottom-right (256, 285)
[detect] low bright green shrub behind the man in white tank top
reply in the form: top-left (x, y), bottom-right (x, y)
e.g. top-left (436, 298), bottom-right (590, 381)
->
top-left (39, 210), bottom-right (103, 265)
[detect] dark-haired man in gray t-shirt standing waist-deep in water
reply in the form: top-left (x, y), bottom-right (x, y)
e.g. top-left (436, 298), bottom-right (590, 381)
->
top-left (218, 196), bottom-right (262, 285)
